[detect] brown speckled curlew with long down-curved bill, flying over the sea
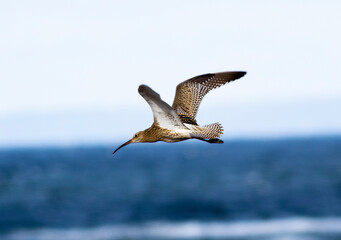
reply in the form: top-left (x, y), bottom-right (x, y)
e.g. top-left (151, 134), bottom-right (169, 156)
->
top-left (113, 72), bottom-right (246, 154)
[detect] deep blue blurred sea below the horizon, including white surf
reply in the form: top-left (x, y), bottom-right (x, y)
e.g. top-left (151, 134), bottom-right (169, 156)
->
top-left (0, 136), bottom-right (341, 240)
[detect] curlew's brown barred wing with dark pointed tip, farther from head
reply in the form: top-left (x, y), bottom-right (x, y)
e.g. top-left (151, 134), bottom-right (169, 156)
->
top-left (173, 72), bottom-right (246, 125)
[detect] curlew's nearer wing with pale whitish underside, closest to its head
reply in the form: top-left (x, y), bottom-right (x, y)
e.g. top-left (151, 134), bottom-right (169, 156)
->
top-left (139, 85), bottom-right (187, 129)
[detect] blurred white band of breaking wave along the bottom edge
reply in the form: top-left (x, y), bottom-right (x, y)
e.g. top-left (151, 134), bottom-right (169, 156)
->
top-left (0, 218), bottom-right (341, 240)
